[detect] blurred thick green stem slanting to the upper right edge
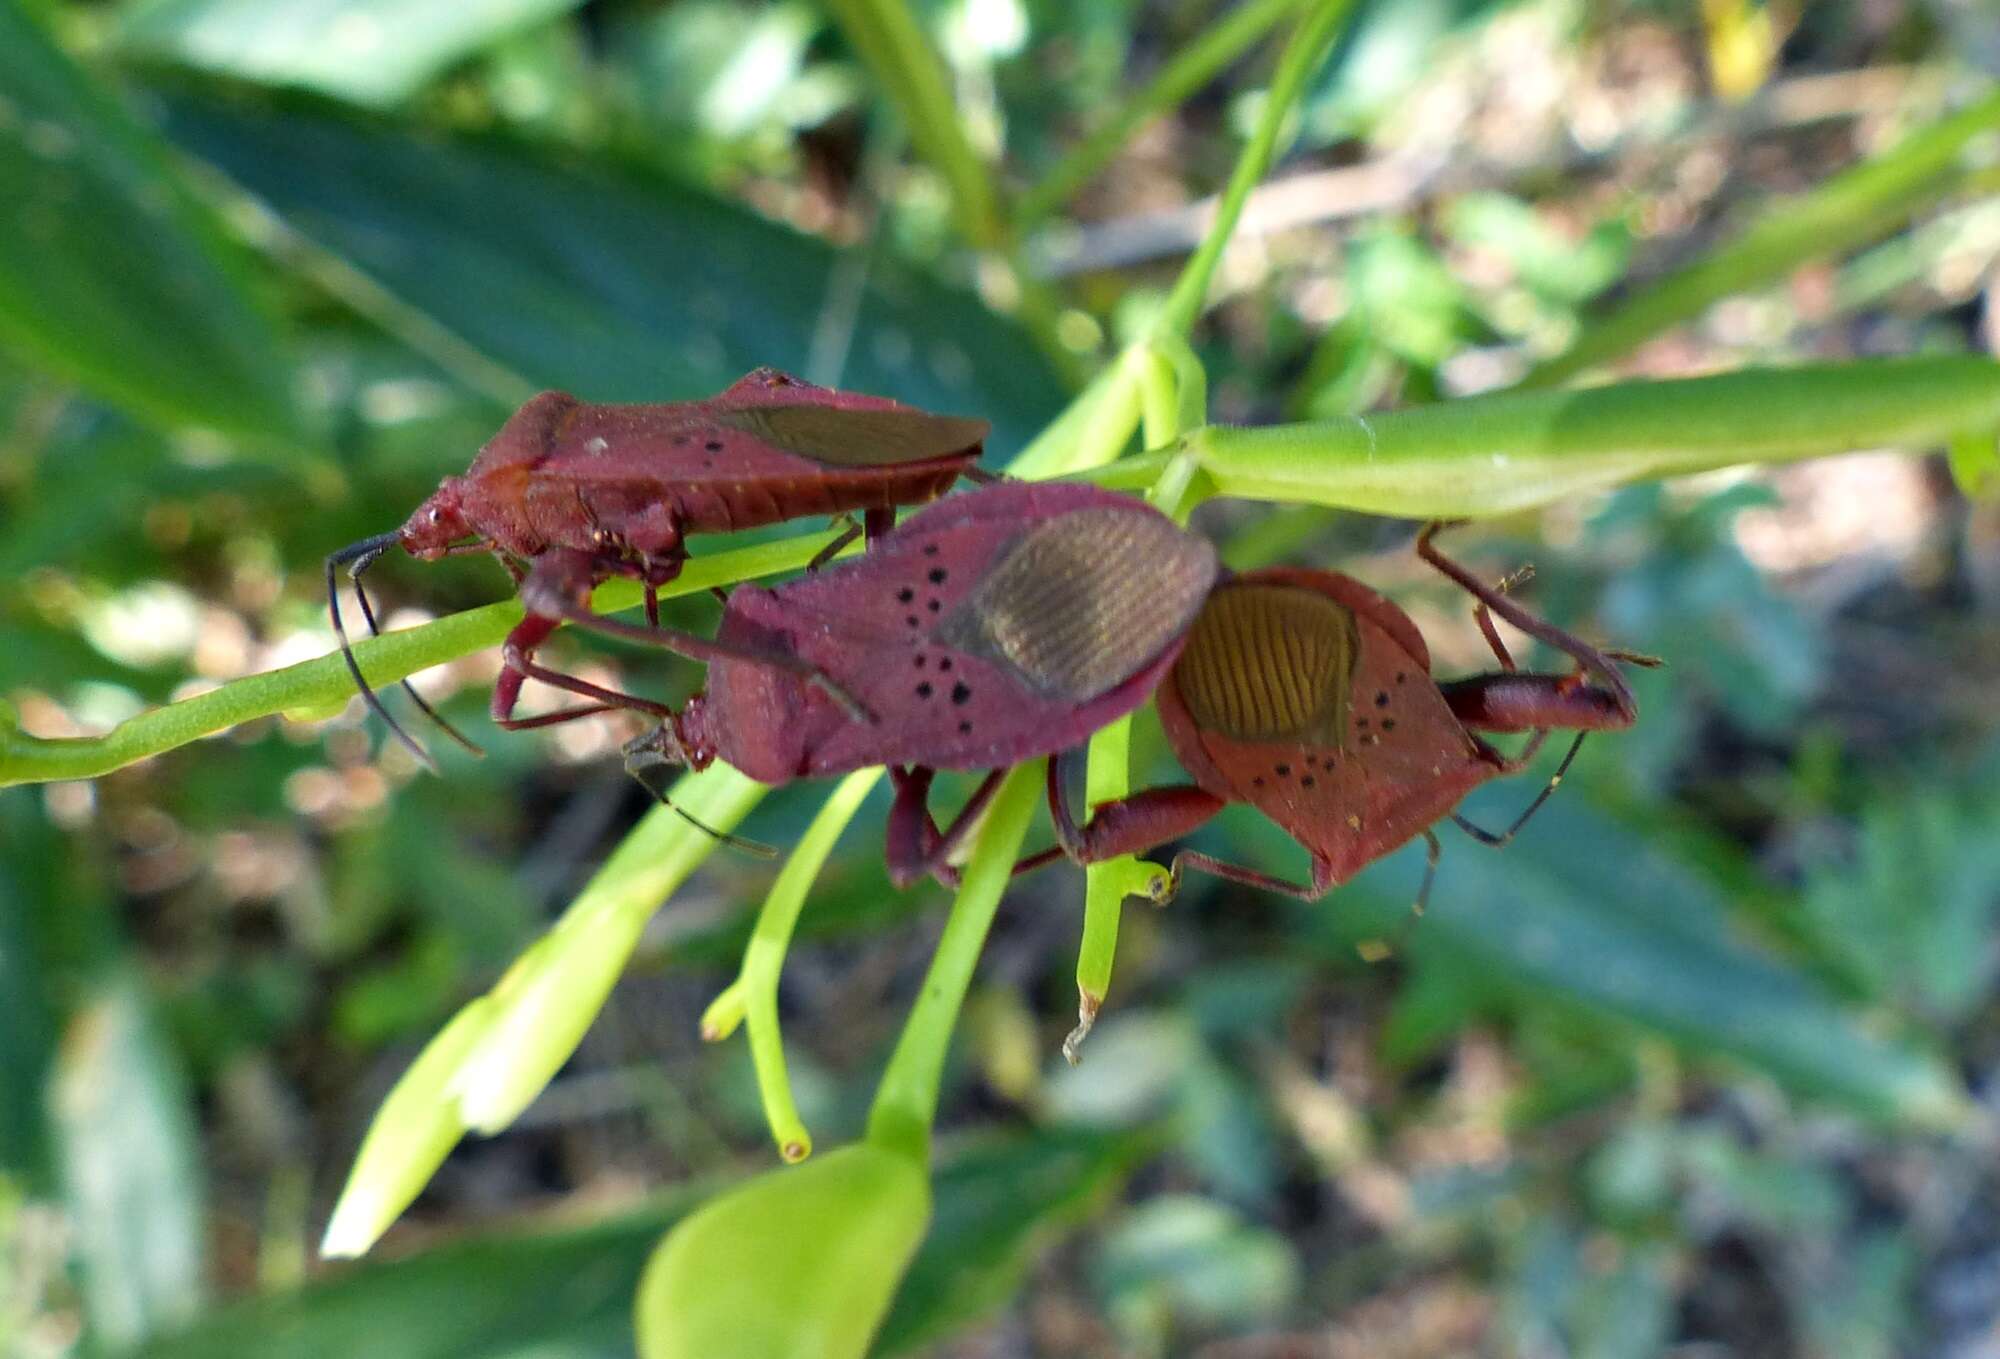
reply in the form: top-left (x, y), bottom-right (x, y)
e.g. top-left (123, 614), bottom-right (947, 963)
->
top-left (1520, 94), bottom-right (2000, 388)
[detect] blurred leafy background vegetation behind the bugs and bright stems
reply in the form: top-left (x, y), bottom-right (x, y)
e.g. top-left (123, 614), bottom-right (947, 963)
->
top-left (0, 0), bottom-right (2000, 1359)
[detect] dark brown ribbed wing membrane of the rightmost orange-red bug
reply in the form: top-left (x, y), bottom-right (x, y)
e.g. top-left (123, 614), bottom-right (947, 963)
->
top-left (1174, 586), bottom-right (1356, 749)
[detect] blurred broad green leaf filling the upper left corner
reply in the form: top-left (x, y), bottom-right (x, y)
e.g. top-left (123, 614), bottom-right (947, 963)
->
top-left (0, 0), bottom-right (296, 442)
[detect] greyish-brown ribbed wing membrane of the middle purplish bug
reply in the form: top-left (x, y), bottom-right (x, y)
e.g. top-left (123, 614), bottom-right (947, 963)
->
top-left (932, 510), bottom-right (1216, 703)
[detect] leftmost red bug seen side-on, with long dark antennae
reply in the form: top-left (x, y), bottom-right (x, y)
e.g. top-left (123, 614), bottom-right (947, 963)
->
top-left (326, 368), bottom-right (988, 763)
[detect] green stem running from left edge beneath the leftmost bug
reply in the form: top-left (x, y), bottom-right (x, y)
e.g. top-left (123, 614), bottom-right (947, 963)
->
top-left (0, 534), bottom-right (858, 787)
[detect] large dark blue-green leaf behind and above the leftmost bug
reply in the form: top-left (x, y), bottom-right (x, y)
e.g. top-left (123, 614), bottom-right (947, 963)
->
top-left (156, 91), bottom-right (1060, 448)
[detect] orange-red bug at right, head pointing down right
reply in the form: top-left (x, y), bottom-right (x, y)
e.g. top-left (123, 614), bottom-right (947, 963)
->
top-left (1050, 524), bottom-right (1658, 905)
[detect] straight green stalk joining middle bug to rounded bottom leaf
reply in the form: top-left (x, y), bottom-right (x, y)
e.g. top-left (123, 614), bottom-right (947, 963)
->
top-left (868, 759), bottom-right (1046, 1157)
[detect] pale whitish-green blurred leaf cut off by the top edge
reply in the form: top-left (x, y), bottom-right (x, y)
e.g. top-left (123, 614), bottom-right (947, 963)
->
top-left (120, 0), bottom-right (582, 104)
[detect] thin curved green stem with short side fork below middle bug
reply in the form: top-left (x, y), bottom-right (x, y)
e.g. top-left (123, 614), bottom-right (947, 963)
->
top-left (702, 767), bottom-right (882, 1161)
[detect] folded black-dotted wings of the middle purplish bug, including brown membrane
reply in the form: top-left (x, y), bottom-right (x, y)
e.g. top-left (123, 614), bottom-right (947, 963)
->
top-left (760, 486), bottom-right (1216, 773)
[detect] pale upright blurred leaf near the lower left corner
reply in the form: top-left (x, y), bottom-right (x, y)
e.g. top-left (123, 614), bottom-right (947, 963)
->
top-left (48, 975), bottom-right (206, 1345)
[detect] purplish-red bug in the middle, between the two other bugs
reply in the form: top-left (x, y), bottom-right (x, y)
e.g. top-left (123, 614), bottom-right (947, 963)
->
top-left (626, 482), bottom-right (1218, 885)
